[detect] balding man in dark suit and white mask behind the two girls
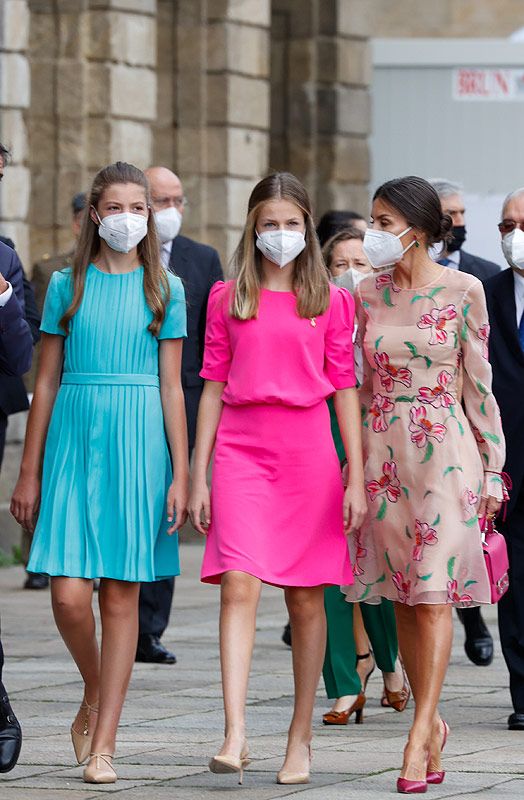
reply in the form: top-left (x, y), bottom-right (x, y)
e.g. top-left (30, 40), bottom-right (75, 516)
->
top-left (136, 167), bottom-right (223, 664)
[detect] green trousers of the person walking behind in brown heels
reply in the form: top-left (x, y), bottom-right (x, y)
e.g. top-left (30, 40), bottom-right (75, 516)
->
top-left (322, 586), bottom-right (398, 698)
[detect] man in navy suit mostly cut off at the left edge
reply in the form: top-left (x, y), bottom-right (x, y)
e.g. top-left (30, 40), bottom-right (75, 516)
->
top-left (0, 144), bottom-right (33, 772)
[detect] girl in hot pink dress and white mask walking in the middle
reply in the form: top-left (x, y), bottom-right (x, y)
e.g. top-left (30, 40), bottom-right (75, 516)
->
top-left (190, 173), bottom-right (366, 783)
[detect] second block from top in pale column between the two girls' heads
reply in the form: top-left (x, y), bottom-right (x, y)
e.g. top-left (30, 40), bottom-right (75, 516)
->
top-left (208, 23), bottom-right (270, 78)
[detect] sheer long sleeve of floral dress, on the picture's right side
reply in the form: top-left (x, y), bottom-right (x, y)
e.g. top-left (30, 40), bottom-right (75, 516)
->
top-left (460, 281), bottom-right (507, 500)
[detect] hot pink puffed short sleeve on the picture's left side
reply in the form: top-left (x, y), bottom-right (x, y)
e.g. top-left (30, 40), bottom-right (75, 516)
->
top-left (200, 281), bottom-right (231, 383)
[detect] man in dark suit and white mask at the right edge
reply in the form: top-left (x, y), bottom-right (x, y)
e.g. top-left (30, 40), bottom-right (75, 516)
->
top-left (484, 188), bottom-right (524, 730)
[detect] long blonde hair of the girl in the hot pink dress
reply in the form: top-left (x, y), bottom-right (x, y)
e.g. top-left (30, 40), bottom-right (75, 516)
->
top-left (231, 172), bottom-right (329, 319)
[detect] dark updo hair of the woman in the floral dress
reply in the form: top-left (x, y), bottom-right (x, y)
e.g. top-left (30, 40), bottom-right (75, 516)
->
top-left (373, 175), bottom-right (453, 247)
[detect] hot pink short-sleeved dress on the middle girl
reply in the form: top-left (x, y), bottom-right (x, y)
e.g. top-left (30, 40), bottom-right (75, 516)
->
top-left (200, 281), bottom-right (356, 586)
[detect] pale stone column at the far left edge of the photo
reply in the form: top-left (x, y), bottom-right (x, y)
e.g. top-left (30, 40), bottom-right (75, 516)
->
top-left (0, 0), bottom-right (31, 268)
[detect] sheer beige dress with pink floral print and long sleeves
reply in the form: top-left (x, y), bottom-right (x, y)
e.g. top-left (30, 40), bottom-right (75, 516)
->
top-left (343, 267), bottom-right (505, 606)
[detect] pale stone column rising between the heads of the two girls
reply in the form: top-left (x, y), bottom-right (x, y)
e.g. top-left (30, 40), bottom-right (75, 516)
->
top-left (207, 0), bottom-right (271, 255)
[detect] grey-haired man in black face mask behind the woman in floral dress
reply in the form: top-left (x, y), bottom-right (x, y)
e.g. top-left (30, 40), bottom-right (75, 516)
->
top-left (431, 178), bottom-right (500, 667)
